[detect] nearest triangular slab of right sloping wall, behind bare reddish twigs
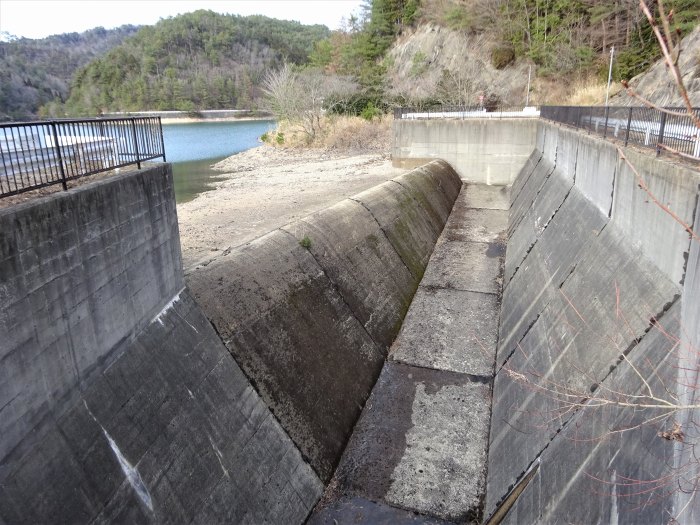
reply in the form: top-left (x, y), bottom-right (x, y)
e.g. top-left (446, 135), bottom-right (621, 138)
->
top-left (503, 303), bottom-right (680, 524)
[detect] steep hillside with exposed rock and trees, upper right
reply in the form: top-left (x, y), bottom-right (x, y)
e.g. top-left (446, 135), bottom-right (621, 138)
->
top-left (366, 0), bottom-right (700, 105)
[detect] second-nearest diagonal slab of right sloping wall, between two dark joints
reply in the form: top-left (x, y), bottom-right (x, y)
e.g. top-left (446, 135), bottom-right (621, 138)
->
top-left (487, 225), bottom-right (679, 511)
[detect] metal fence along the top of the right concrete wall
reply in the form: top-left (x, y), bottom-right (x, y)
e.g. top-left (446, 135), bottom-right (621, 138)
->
top-left (540, 106), bottom-right (700, 160)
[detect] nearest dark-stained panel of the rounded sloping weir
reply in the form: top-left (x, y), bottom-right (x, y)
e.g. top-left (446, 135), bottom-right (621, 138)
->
top-left (188, 227), bottom-right (384, 480)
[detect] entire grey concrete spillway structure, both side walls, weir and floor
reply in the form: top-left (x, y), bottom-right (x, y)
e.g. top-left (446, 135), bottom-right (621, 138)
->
top-left (0, 119), bottom-right (700, 524)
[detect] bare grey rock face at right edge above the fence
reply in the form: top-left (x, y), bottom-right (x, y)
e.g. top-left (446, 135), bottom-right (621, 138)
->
top-left (611, 26), bottom-right (700, 107)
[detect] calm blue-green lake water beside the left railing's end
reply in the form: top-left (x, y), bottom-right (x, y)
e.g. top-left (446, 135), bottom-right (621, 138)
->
top-left (163, 120), bottom-right (275, 204)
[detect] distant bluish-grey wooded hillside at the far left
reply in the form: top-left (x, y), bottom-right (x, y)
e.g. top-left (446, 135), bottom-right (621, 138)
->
top-left (0, 26), bottom-right (138, 120)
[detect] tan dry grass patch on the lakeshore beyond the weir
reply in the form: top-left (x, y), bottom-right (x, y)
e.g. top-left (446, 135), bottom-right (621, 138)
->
top-left (267, 116), bottom-right (393, 154)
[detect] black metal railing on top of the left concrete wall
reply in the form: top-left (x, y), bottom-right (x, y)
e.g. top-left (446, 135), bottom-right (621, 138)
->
top-left (0, 117), bottom-right (165, 197)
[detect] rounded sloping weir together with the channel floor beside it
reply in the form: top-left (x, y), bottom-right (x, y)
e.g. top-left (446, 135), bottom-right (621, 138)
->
top-left (183, 162), bottom-right (508, 523)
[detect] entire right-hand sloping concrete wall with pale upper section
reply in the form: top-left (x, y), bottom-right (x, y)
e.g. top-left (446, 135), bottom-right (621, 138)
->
top-left (485, 122), bottom-right (700, 523)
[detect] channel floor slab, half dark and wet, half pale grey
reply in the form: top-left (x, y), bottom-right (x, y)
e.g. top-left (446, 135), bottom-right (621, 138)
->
top-left (326, 362), bottom-right (490, 521)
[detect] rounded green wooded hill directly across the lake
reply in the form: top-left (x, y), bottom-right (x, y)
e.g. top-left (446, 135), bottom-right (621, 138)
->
top-left (46, 10), bottom-right (330, 115)
